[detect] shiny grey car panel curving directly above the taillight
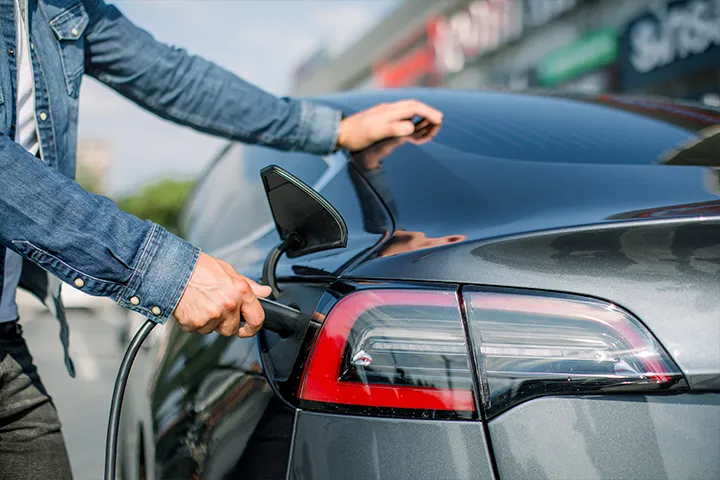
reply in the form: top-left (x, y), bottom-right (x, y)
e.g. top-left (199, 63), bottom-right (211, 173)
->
top-left (349, 218), bottom-right (720, 391)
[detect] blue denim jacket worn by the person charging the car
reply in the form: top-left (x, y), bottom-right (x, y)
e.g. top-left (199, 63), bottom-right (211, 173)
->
top-left (0, 0), bottom-right (340, 374)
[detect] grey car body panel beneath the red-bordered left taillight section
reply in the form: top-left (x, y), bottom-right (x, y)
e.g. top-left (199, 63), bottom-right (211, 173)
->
top-left (288, 411), bottom-right (494, 480)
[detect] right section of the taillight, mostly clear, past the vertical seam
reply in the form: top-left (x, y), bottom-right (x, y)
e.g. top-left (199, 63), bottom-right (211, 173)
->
top-left (463, 289), bottom-right (684, 416)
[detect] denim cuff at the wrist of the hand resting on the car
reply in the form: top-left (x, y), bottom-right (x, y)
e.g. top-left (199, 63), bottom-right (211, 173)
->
top-left (300, 101), bottom-right (342, 155)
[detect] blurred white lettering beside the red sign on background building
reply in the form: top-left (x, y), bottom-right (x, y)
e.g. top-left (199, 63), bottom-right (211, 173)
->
top-left (433, 0), bottom-right (522, 74)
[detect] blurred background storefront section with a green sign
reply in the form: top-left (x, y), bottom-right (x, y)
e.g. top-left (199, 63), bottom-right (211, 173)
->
top-left (537, 28), bottom-right (618, 93)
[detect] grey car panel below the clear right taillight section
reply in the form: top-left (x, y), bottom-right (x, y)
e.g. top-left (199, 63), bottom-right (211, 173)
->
top-left (489, 394), bottom-right (720, 480)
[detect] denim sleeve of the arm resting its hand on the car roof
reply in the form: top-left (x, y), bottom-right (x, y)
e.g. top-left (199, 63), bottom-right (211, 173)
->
top-left (84, 0), bottom-right (341, 155)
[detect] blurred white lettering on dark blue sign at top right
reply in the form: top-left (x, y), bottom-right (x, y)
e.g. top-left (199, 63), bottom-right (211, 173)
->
top-left (628, 0), bottom-right (720, 73)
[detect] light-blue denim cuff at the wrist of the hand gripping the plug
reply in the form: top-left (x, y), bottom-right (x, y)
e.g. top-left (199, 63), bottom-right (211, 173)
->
top-left (117, 224), bottom-right (200, 324)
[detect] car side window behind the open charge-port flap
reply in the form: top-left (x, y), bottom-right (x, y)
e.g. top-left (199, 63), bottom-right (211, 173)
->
top-left (184, 144), bottom-right (328, 251)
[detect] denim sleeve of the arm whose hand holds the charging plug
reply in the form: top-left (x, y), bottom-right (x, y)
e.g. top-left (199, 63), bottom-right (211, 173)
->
top-left (0, 137), bottom-right (200, 323)
